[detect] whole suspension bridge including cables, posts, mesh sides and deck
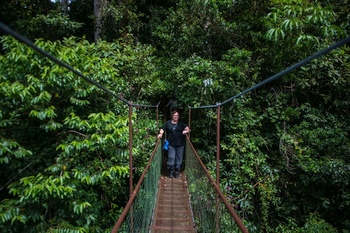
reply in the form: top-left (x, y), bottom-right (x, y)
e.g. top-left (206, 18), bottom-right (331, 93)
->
top-left (0, 23), bottom-right (350, 233)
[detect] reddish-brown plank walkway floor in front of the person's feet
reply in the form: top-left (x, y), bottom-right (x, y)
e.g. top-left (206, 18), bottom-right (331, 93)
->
top-left (151, 172), bottom-right (196, 233)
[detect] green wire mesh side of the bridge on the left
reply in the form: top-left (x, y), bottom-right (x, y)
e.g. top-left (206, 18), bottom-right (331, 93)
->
top-left (112, 140), bottom-right (162, 233)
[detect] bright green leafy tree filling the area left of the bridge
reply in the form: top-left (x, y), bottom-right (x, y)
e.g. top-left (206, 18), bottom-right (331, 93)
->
top-left (0, 37), bottom-right (156, 232)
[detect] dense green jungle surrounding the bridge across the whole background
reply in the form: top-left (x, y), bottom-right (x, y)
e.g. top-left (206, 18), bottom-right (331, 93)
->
top-left (0, 0), bottom-right (350, 233)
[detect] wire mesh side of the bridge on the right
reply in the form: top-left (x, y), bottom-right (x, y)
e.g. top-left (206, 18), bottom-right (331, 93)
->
top-left (185, 136), bottom-right (248, 233)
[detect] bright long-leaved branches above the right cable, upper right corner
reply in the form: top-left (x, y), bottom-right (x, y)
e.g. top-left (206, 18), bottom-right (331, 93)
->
top-left (263, 0), bottom-right (346, 72)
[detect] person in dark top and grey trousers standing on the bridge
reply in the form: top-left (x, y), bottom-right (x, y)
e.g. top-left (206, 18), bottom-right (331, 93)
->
top-left (158, 111), bottom-right (190, 178)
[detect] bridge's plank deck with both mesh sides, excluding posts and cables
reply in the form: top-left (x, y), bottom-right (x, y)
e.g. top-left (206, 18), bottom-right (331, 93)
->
top-left (112, 136), bottom-right (248, 233)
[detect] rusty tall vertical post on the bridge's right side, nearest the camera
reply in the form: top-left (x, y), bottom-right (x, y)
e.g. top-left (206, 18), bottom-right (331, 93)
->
top-left (215, 103), bottom-right (220, 232)
